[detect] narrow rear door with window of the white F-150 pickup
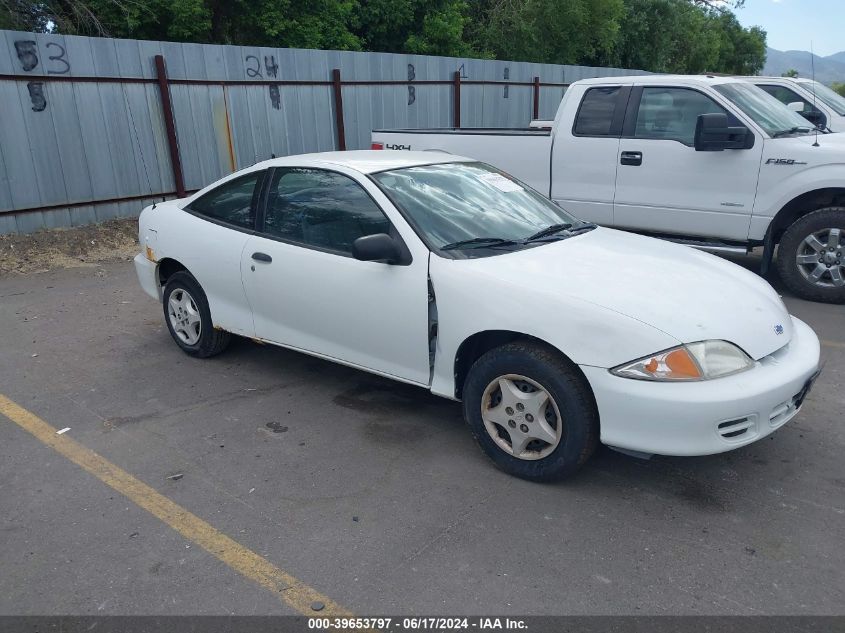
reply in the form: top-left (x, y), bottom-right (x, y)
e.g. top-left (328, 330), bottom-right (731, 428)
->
top-left (550, 85), bottom-right (630, 226)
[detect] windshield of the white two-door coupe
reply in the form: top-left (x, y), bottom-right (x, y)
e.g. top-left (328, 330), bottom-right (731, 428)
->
top-left (373, 163), bottom-right (593, 255)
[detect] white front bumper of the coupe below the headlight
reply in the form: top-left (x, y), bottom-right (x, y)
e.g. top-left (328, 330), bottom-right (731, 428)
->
top-left (581, 317), bottom-right (820, 455)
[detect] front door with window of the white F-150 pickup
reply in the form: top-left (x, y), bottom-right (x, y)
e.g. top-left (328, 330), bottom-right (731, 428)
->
top-left (613, 86), bottom-right (763, 240)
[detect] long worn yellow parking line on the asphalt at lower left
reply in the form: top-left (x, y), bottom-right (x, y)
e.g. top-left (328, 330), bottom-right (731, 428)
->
top-left (0, 394), bottom-right (351, 617)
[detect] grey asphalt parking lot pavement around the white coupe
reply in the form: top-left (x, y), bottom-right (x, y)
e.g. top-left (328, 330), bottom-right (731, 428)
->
top-left (0, 258), bottom-right (845, 615)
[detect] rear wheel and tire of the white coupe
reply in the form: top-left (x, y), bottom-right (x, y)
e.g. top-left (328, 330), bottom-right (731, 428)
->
top-left (162, 272), bottom-right (231, 358)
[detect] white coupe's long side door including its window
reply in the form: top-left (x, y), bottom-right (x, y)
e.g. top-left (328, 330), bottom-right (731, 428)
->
top-left (242, 167), bottom-right (430, 385)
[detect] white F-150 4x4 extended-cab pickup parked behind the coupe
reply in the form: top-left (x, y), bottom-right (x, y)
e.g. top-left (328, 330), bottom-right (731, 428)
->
top-left (372, 75), bottom-right (845, 303)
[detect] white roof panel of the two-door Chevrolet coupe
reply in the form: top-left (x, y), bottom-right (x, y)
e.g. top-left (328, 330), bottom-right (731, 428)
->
top-left (254, 149), bottom-right (473, 174)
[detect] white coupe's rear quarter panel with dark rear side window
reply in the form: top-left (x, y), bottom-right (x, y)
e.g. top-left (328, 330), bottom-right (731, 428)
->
top-left (171, 170), bottom-right (267, 336)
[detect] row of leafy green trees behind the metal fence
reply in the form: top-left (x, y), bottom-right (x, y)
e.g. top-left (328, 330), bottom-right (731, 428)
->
top-left (0, 0), bottom-right (766, 74)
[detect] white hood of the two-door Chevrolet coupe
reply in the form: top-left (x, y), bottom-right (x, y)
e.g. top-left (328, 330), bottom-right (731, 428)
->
top-left (462, 227), bottom-right (792, 359)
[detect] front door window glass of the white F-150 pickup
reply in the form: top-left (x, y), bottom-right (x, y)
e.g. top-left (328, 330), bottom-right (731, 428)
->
top-left (634, 87), bottom-right (738, 147)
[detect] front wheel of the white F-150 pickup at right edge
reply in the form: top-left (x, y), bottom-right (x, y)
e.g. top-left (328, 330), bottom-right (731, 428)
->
top-left (777, 207), bottom-right (845, 303)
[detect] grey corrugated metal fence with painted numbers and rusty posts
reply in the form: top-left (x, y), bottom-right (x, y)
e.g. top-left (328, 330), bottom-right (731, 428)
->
top-left (0, 31), bottom-right (638, 234)
